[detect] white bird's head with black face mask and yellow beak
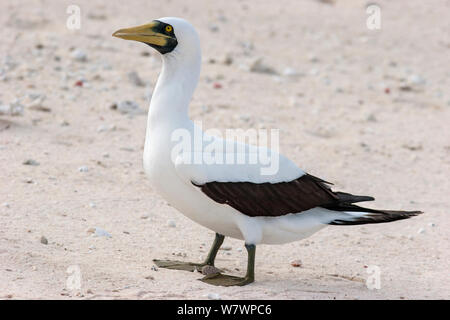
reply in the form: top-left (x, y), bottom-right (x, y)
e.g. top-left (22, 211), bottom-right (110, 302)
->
top-left (113, 17), bottom-right (200, 55)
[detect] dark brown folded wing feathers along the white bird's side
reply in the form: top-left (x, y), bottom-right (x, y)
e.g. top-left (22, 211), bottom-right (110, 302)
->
top-left (193, 174), bottom-right (374, 217)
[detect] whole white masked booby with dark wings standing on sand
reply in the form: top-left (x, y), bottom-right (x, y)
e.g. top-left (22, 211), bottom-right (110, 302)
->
top-left (113, 17), bottom-right (421, 286)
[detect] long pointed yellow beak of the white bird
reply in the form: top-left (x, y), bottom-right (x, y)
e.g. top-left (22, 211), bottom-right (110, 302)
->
top-left (113, 21), bottom-right (172, 47)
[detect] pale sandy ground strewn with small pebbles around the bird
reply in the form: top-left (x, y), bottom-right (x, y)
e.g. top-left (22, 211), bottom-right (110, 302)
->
top-left (0, 0), bottom-right (450, 299)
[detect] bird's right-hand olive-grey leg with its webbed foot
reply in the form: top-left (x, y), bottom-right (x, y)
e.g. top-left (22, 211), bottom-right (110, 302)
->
top-left (200, 244), bottom-right (256, 287)
